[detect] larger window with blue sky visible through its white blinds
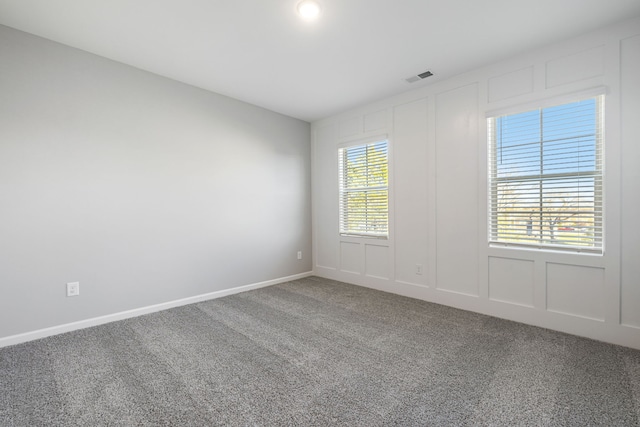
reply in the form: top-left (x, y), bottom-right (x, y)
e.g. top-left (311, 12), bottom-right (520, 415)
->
top-left (488, 96), bottom-right (604, 253)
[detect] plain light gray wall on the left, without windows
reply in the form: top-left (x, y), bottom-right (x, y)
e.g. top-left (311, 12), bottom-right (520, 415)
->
top-left (0, 26), bottom-right (311, 338)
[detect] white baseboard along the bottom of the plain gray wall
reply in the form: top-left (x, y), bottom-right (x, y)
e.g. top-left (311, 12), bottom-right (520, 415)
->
top-left (0, 271), bottom-right (313, 348)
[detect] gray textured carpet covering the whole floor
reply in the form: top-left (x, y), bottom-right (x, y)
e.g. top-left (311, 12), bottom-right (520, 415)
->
top-left (0, 277), bottom-right (640, 427)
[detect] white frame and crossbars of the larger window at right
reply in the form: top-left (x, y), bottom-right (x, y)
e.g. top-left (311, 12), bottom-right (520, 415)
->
top-left (487, 88), bottom-right (606, 255)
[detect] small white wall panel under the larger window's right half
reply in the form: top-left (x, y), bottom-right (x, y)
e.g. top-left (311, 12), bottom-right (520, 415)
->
top-left (547, 263), bottom-right (604, 320)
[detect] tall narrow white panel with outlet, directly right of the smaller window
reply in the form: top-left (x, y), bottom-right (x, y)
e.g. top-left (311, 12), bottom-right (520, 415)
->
top-left (393, 99), bottom-right (428, 286)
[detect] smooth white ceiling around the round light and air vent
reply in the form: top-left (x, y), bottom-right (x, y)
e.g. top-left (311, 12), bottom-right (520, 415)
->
top-left (0, 0), bottom-right (640, 121)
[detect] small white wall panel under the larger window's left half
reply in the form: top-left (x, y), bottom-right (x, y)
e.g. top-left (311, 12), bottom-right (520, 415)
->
top-left (489, 257), bottom-right (534, 307)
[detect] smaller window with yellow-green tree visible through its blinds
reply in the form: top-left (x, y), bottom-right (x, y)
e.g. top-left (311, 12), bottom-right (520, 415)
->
top-left (338, 141), bottom-right (389, 237)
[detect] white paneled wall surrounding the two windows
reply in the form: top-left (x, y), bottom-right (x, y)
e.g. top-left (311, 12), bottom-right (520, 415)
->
top-left (311, 19), bottom-right (640, 349)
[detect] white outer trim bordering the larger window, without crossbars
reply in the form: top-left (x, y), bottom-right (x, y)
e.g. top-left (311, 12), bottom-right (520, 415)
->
top-left (485, 91), bottom-right (607, 255)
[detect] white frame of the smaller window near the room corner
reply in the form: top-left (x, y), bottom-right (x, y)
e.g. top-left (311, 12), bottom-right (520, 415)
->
top-left (338, 135), bottom-right (390, 239)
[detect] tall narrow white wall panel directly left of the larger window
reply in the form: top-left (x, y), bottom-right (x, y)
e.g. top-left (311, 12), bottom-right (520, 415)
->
top-left (436, 84), bottom-right (479, 295)
